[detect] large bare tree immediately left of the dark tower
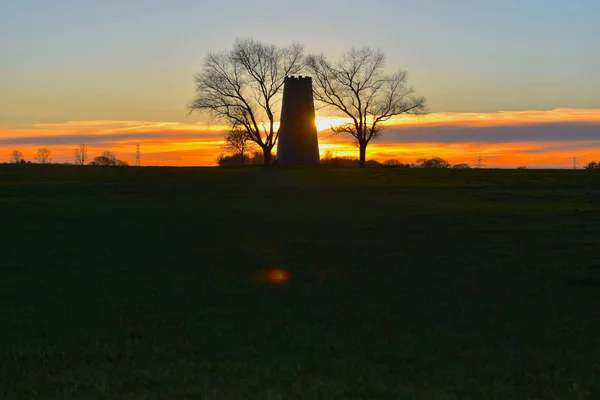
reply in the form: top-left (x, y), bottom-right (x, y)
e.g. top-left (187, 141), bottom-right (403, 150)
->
top-left (189, 39), bottom-right (304, 165)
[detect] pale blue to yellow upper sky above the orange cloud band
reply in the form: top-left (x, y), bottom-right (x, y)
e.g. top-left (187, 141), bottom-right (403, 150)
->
top-left (0, 0), bottom-right (600, 125)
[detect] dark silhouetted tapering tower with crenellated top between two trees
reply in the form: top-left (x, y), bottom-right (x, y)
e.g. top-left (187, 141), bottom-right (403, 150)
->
top-left (277, 76), bottom-right (320, 165)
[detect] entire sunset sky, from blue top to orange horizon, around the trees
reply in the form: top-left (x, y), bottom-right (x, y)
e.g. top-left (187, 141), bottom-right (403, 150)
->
top-left (0, 0), bottom-right (600, 168)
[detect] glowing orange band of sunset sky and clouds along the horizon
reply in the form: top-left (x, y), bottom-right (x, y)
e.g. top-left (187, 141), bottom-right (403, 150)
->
top-left (0, 109), bottom-right (600, 168)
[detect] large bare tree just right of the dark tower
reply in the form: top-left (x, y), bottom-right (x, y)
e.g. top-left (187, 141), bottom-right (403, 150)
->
top-left (307, 47), bottom-right (426, 168)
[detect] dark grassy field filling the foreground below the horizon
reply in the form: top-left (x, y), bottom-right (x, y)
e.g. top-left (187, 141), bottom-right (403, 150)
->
top-left (0, 165), bottom-right (600, 400)
